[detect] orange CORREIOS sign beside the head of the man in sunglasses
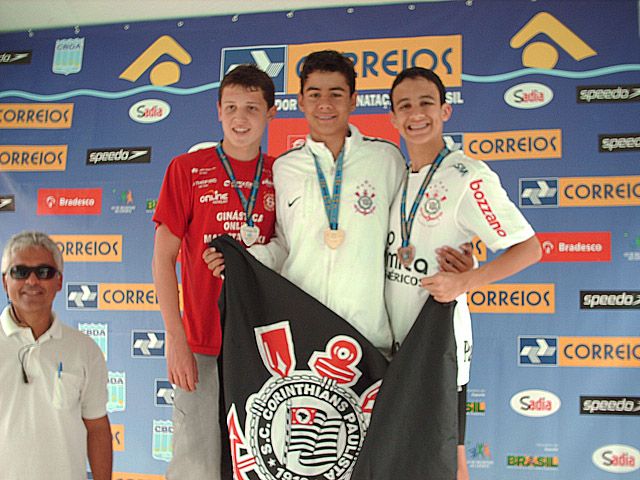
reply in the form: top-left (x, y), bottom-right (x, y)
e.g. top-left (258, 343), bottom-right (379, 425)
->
top-left (51, 235), bottom-right (122, 262)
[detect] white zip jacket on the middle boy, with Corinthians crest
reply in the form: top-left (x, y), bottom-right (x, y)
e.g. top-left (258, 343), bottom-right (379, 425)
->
top-left (249, 126), bottom-right (405, 353)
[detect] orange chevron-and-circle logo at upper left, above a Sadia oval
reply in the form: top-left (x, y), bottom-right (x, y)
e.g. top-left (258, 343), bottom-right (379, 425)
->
top-left (118, 35), bottom-right (191, 86)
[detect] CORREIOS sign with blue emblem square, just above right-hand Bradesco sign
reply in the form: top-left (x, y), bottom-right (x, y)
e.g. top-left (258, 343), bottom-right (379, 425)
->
top-left (519, 176), bottom-right (640, 208)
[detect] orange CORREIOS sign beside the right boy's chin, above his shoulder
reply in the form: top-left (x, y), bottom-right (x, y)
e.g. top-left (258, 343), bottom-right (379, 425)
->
top-left (464, 129), bottom-right (562, 160)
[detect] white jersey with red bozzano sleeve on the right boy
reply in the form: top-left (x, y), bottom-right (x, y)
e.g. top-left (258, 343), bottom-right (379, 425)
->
top-left (385, 142), bottom-right (534, 385)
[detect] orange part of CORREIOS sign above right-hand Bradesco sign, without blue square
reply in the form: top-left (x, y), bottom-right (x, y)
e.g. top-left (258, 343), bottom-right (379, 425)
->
top-left (558, 176), bottom-right (640, 207)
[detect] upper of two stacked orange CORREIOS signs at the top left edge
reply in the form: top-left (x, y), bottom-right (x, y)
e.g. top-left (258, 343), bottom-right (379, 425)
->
top-left (0, 103), bottom-right (73, 129)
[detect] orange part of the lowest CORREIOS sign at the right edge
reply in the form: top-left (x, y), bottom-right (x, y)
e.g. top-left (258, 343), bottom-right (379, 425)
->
top-left (558, 337), bottom-right (640, 368)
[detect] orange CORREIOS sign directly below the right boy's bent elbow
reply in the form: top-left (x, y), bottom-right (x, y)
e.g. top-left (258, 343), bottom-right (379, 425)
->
top-left (467, 283), bottom-right (555, 313)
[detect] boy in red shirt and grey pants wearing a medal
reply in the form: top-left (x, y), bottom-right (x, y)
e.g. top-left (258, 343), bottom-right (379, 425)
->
top-left (152, 65), bottom-right (276, 480)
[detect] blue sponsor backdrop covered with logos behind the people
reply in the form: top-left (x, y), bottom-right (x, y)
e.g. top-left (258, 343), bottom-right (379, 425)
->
top-left (0, 0), bottom-right (640, 480)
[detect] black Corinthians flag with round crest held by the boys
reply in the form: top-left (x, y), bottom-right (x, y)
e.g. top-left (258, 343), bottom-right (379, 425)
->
top-left (212, 236), bottom-right (458, 480)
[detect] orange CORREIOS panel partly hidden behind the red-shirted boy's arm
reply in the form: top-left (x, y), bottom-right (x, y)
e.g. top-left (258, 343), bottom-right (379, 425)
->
top-left (98, 283), bottom-right (183, 311)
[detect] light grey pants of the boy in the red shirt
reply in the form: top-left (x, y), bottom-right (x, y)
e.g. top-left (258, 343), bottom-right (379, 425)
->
top-left (166, 354), bottom-right (220, 480)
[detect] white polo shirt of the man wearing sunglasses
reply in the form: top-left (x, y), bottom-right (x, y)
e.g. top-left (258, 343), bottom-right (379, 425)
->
top-left (0, 307), bottom-right (107, 480)
